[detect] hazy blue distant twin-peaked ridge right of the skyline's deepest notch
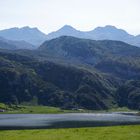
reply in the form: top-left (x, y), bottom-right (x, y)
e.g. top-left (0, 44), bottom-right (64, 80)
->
top-left (47, 25), bottom-right (140, 46)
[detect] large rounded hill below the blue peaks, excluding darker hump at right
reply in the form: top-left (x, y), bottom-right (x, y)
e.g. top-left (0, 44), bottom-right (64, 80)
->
top-left (38, 36), bottom-right (140, 65)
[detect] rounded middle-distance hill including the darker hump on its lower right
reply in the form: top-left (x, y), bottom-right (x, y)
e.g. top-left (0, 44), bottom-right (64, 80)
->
top-left (38, 36), bottom-right (140, 79)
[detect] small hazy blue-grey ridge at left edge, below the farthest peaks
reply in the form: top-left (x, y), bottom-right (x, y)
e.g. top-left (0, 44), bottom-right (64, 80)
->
top-left (0, 37), bottom-right (36, 50)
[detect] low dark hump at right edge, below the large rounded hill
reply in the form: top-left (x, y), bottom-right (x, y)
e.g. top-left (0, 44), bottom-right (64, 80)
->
top-left (95, 57), bottom-right (140, 80)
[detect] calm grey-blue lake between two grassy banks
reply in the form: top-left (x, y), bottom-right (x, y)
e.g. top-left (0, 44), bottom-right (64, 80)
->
top-left (0, 113), bottom-right (140, 130)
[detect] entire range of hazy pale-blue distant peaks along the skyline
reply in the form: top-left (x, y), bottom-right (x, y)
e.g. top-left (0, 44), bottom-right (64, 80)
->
top-left (0, 25), bottom-right (140, 47)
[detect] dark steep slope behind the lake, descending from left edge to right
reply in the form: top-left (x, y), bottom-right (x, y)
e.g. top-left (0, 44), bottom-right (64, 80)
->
top-left (0, 52), bottom-right (119, 109)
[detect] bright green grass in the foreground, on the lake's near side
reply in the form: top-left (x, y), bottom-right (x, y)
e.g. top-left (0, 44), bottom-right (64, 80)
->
top-left (0, 125), bottom-right (140, 140)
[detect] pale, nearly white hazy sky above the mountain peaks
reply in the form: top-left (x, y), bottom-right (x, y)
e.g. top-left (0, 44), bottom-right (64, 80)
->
top-left (0, 0), bottom-right (140, 35)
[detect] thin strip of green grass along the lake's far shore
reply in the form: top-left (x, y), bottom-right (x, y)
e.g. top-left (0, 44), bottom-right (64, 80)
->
top-left (0, 103), bottom-right (136, 114)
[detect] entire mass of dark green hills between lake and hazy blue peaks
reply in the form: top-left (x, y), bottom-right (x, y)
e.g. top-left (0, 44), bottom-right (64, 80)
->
top-left (0, 36), bottom-right (140, 110)
